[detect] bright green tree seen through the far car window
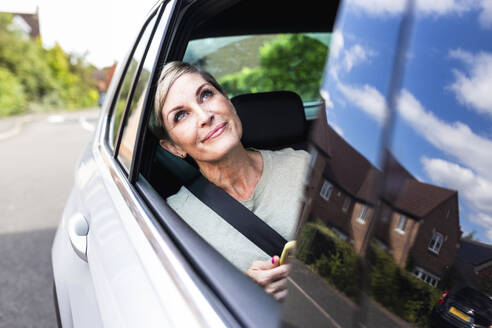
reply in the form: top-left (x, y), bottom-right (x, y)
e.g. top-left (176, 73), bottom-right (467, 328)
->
top-left (219, 34), bottom-right (328, 101)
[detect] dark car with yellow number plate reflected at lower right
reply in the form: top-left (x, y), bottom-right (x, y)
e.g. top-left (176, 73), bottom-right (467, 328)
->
top-left (432, 287), bottom-right (492, 328)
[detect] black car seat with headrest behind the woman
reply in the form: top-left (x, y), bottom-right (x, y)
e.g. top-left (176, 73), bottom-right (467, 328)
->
top-left (149, 91), bottom-right (308, 199)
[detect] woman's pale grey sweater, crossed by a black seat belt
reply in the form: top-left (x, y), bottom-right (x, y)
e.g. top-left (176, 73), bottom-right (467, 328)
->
top-left (167, 148), bottom-right (309, 271)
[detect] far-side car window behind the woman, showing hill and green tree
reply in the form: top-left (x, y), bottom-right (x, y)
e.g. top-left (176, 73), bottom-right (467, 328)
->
top-left (183, 33), bottom-right (331, 119)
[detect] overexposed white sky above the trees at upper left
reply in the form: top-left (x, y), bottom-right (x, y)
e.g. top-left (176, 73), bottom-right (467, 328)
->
top-left (0, 0), bottom-right (157, 68)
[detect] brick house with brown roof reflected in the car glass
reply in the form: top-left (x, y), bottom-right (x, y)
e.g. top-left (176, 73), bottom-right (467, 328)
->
top-left (301, 113), bottom-right (462, 286)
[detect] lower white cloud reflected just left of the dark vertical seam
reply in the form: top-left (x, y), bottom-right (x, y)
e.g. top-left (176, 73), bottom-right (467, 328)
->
top-left (337, 82), bottom-right (387, 124)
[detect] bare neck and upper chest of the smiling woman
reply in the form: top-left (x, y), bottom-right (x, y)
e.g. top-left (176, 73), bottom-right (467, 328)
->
top-left (197, 145), bottom-right (263, 201)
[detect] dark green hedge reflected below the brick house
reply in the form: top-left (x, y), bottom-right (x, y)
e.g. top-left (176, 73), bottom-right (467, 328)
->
top-left (296, 223), bottom-right (442, 327)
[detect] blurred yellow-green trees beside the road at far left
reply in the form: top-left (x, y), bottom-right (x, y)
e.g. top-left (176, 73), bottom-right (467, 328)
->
top-left (0, 13), bottom-right (99, 115)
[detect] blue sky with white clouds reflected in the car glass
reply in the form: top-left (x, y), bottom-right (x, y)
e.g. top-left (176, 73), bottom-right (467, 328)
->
top-left (324, 0), bottom-right (492, 243)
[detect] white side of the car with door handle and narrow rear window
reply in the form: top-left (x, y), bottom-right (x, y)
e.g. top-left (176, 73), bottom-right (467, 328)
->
top-left (55, 1), bottom-right (225, 327)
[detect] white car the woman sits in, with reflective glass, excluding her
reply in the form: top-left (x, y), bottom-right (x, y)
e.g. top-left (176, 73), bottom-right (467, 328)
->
top-left (52, 0), bottom-right (492, 327)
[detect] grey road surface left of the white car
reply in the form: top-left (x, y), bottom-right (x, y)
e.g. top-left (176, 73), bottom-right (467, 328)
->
top-left (0, 110), bottom-right (98, 328)
